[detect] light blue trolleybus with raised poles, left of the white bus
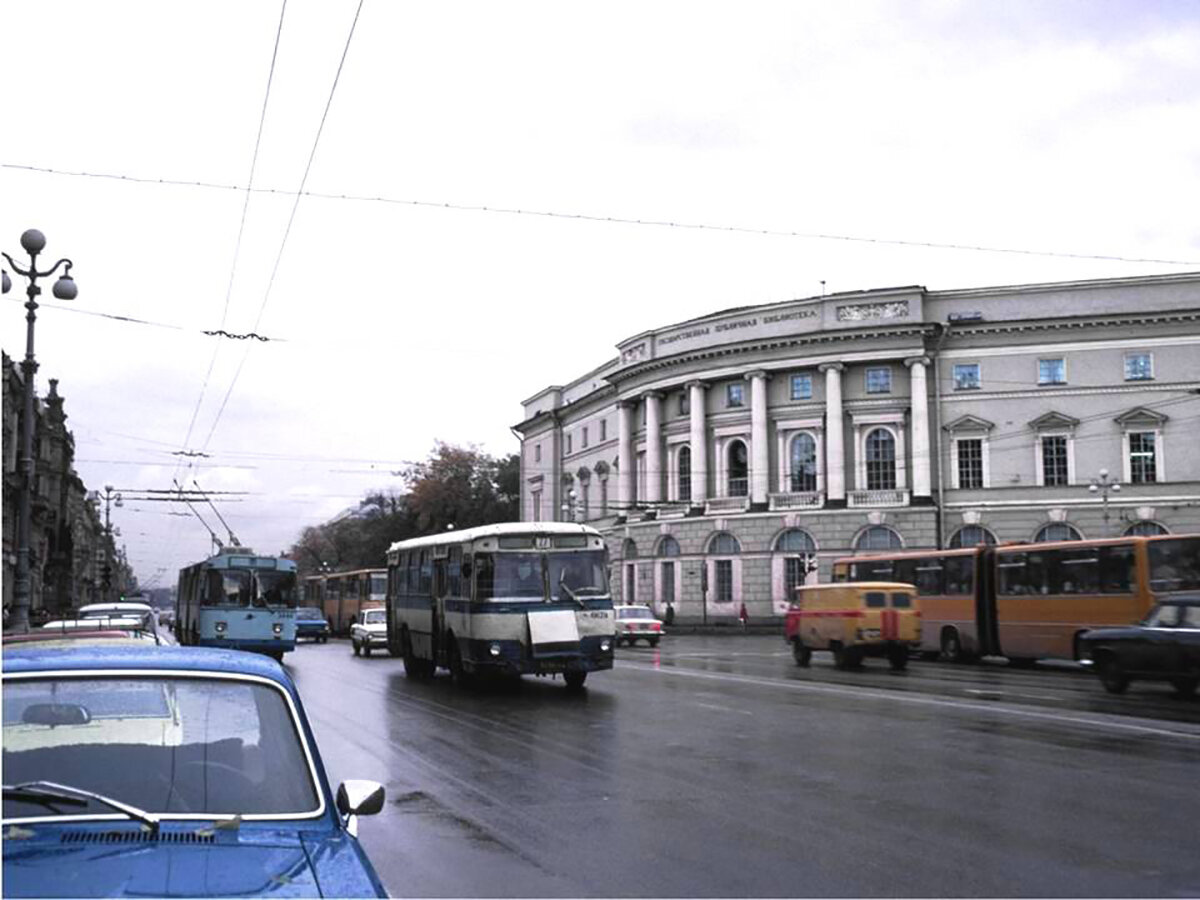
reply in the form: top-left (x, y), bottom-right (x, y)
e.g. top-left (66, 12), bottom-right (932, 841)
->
top-left (175, 547), bottom-right (299, 660)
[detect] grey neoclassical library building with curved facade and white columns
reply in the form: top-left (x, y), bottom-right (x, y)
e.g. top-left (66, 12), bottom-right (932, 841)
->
top-left (515, 272), bottom-right (1200, 622)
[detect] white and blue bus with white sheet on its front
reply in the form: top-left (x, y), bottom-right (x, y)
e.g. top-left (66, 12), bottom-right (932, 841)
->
top-left (388, 522), bottom-right (616, 688)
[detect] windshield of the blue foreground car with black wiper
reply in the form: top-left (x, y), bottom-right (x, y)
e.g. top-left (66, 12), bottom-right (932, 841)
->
top-left (4, 676), bottom-right (319, 820)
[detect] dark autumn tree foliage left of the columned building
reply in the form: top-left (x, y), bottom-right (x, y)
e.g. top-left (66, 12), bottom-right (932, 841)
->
top-left (288, 440), bottom-right (520, 575)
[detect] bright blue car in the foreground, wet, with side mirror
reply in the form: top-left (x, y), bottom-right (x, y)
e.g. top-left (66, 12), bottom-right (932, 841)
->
top-left (2, 640), bottom-right (386, 896)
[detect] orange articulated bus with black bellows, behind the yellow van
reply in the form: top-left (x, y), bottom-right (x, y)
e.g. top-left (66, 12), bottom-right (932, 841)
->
top-left (834, 535), bottom-right (1200, 662)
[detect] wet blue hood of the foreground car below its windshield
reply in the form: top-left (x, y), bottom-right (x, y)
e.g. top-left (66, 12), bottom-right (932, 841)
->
top-left (4, 826), bottom-right (376, 898)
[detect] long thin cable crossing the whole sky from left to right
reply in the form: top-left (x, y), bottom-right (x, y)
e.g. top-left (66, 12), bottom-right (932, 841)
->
top-left (0, 163), bottom-right (1200, 266)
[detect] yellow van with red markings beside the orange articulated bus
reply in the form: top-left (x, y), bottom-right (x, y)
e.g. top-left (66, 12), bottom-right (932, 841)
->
top-left (784, 581), bottom-right (920, 670)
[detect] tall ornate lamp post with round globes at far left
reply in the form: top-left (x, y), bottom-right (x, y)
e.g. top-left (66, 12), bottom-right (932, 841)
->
top-left (0, 228), bottom-right (78, 634)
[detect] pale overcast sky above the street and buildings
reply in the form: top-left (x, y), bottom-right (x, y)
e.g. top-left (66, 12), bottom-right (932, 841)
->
top-left (0, 0), bottom-right (1200, 584)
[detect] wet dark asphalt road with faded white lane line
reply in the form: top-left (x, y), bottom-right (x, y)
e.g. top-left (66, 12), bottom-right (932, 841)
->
top-left (286, 635), bottom-right (1200, 896)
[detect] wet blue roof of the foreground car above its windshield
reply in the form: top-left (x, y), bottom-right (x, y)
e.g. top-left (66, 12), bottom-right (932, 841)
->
top-left (4, 641), bottom-right (292, 691)
